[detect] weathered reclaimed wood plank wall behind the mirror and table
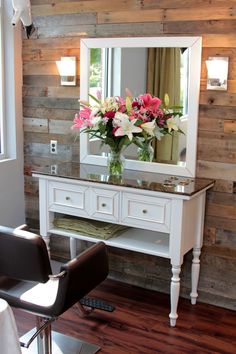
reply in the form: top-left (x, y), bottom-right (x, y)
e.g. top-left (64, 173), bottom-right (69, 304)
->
top-left (22, 0), bottom-right (236, 308)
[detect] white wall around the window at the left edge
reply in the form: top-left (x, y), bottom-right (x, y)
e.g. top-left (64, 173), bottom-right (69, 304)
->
top-left (0, 1), bottom-right (25, 227)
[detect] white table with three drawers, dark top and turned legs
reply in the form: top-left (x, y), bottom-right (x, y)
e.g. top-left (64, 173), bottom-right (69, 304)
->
top-left (33, 163), bottom-right (214, 326)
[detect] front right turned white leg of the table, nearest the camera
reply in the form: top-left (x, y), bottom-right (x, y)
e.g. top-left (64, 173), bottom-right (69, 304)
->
top-left (169, 266), bottom-right (181, 327)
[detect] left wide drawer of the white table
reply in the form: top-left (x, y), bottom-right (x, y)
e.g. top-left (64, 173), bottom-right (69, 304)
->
top-left (49, 182), bottom-right (89, 216)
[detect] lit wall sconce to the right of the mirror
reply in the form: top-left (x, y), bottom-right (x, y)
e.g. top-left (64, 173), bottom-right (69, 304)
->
top-left (206, 57), bottom-right (229, 91)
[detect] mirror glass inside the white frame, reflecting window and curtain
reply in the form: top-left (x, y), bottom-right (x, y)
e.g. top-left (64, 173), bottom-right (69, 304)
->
top-left (89, 47), bottom-right (189, 165)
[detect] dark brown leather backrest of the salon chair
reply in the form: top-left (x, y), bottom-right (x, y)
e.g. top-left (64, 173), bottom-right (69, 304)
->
top-left (0, 226), bottom-right (52, 283)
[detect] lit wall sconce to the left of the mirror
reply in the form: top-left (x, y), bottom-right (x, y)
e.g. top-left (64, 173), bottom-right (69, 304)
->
top-left (56, 57), bottom-right (76, 86)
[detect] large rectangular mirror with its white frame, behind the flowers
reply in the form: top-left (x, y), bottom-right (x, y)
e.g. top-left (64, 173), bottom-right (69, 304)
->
top-left (80, 36), bottom-right (202, 177)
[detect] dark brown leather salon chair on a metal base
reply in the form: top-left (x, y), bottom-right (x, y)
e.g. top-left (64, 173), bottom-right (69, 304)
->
top-left (0, 226), bottom-right (108, 354)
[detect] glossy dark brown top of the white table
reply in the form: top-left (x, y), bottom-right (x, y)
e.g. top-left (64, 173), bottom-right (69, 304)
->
top-left (32, 162), bottom-right (214, 196)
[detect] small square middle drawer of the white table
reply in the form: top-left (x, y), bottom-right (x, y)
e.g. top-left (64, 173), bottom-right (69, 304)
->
top-left (90, 188), bottom-right (120, 221)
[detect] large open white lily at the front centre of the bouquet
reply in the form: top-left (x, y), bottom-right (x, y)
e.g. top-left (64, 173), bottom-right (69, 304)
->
top-left (114, 112), bottom-right (142, 141)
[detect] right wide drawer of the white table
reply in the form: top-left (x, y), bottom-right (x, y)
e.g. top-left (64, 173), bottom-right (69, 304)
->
top-left (122, 193), bottom-right (171, 232)
